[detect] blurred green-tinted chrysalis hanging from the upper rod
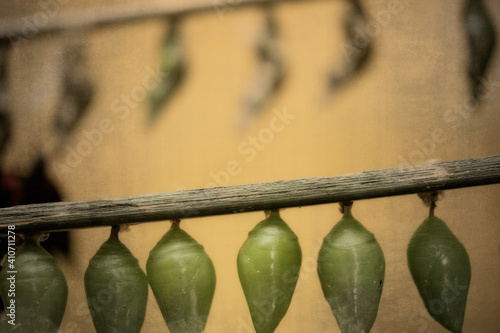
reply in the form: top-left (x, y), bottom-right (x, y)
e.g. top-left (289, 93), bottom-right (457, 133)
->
top-left (149, 17), bottom-right (186, 121)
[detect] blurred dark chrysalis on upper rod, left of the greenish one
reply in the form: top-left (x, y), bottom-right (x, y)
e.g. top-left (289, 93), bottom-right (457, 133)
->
top-left (54, 41), bottom-right (94, 146)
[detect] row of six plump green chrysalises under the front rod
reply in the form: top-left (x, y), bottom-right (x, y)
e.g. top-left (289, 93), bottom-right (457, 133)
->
top-left (0, 193), bottom-right (471, 333)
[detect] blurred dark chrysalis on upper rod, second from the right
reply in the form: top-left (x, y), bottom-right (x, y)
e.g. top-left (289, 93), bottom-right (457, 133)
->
top-left (328, 0), bottom-right (372, 93)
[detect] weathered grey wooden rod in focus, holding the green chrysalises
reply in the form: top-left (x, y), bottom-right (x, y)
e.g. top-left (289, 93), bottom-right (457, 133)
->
top-left (0, 155), bottom-right (500, 231)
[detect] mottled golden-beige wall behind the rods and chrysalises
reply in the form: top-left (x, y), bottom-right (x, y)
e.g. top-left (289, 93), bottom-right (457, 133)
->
top-left (0, 0), bottom-right (500, 333)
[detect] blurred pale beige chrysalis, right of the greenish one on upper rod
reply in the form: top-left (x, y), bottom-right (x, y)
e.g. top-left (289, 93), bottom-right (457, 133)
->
top-left (239, 6), bottom-right (285, 128)
